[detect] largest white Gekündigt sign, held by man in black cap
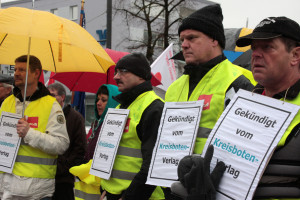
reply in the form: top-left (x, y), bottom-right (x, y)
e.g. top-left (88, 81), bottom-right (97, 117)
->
top-left (203, 89), bottom-right (299, 200)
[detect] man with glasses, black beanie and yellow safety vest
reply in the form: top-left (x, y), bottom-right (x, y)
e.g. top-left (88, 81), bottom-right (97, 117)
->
top-left (100, 53), bottom-right (164, 200)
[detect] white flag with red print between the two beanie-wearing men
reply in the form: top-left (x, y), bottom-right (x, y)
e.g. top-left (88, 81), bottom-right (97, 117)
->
top-left (151, 43), bottom-right (176, 91)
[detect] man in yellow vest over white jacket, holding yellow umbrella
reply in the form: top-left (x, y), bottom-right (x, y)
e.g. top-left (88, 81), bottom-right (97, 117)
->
top-left (0, 55), bottom-right (69, 200)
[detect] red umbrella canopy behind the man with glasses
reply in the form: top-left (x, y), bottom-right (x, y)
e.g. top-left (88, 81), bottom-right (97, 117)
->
top-left (50, 49), bottom-right (161, 93)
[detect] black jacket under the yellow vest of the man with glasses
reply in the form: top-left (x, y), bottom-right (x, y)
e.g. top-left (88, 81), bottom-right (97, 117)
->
top-left (114, 81), bottom-right (164, 200)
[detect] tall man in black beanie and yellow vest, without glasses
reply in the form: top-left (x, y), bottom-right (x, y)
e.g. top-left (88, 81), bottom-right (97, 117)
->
top-left (165, 4), bottom-right (255, 196)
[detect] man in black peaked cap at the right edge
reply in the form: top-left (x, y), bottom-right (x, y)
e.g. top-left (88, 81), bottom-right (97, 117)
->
top-left (236, 17), bottom-right (300, 199)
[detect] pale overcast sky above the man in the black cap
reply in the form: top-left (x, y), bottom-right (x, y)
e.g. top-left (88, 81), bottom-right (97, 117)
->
top-left (212, 0), bottom-right (300, 28)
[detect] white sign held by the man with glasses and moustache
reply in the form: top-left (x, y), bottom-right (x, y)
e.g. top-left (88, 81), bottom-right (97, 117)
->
top-left (90, 108), bottom-right (129, 180)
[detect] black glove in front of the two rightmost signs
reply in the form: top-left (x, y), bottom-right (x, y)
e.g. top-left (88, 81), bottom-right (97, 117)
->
top-left (178, 145), bottom-right (226, 200)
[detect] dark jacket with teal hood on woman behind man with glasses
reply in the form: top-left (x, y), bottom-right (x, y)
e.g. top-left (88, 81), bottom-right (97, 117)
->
top-left (84, 84), bottom-right (120, 162)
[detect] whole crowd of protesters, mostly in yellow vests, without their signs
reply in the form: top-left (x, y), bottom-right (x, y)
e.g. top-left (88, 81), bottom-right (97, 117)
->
top-left (0, 4), bottom-right (300, 200)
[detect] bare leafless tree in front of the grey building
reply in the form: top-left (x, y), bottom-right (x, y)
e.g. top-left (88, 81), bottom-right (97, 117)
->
top-left (114, 0), bottom-right (185, 62)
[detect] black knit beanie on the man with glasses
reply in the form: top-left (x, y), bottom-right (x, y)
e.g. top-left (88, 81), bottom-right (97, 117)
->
top-left (115, 53), bottom-right (152, 81)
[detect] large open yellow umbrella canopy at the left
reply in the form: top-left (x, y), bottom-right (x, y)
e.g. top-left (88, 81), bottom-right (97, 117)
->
top-left (0, 7), bottom-right (114, 73)
